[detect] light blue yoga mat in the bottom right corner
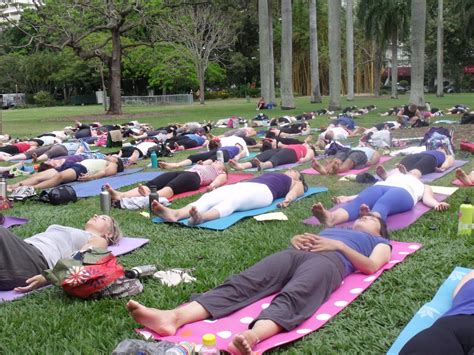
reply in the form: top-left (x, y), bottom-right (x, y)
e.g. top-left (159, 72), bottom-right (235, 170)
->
top-left (387, 266), bottom-right (471, 355)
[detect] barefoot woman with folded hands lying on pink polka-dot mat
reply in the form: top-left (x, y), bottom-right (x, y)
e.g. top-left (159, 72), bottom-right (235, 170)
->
top-left (127, 215), bottom-right (391, 354)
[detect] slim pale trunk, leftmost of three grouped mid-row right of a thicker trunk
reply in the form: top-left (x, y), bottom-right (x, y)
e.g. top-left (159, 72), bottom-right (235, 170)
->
top-left (309, 0), bottom-right (321, 103)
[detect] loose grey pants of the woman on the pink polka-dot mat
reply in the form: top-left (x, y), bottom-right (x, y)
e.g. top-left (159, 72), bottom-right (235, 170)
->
top-left (194, 248), bottom-right (344, 331)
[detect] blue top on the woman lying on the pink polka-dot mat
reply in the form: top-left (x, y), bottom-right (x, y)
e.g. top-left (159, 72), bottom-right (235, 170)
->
top-left (319, 228), bottom-right (391, 277)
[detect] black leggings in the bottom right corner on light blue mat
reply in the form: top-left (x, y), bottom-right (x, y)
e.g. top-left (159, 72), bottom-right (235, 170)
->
top-left (400, 314), bottom-right (474, 355)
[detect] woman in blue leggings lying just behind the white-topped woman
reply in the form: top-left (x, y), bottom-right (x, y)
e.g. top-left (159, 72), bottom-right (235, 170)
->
top-left (377, 147), bottom-right (454, 180)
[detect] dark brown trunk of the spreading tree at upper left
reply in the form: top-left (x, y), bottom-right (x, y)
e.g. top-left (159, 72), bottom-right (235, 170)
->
top-left (107, 30), bottom-right (122, 115)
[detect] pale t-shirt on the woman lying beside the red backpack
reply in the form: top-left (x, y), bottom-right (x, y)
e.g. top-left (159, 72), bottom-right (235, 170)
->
top-left (25, 224), bottom-right (91, 268)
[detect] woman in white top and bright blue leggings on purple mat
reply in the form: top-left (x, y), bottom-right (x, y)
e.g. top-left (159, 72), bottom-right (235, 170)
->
top-left (312, 172), bottom-right (449, 227)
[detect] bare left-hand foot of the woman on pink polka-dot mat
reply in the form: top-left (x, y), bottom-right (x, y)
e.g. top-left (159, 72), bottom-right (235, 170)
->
top-left (126, 300), bottom-right (177, 336)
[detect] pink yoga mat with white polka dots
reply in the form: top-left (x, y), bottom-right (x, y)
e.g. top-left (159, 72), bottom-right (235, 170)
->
top-left (137, 241), bottom-right (421, 354)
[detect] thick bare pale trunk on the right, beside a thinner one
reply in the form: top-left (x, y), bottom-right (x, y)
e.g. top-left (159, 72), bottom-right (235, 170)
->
top-left (410, 0), bottom-right (426, 106)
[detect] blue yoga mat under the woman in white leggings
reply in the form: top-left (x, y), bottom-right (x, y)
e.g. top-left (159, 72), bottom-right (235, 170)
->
top-left (152, 187), bottom-right (328, 230)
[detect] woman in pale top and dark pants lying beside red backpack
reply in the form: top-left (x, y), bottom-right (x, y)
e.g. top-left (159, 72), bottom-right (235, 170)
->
top-left (0, 215), bottom-right (122, 292)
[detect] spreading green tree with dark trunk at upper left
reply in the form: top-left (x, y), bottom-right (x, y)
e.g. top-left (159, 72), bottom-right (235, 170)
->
top-left (0, 0), bottom-right (159, 114)
